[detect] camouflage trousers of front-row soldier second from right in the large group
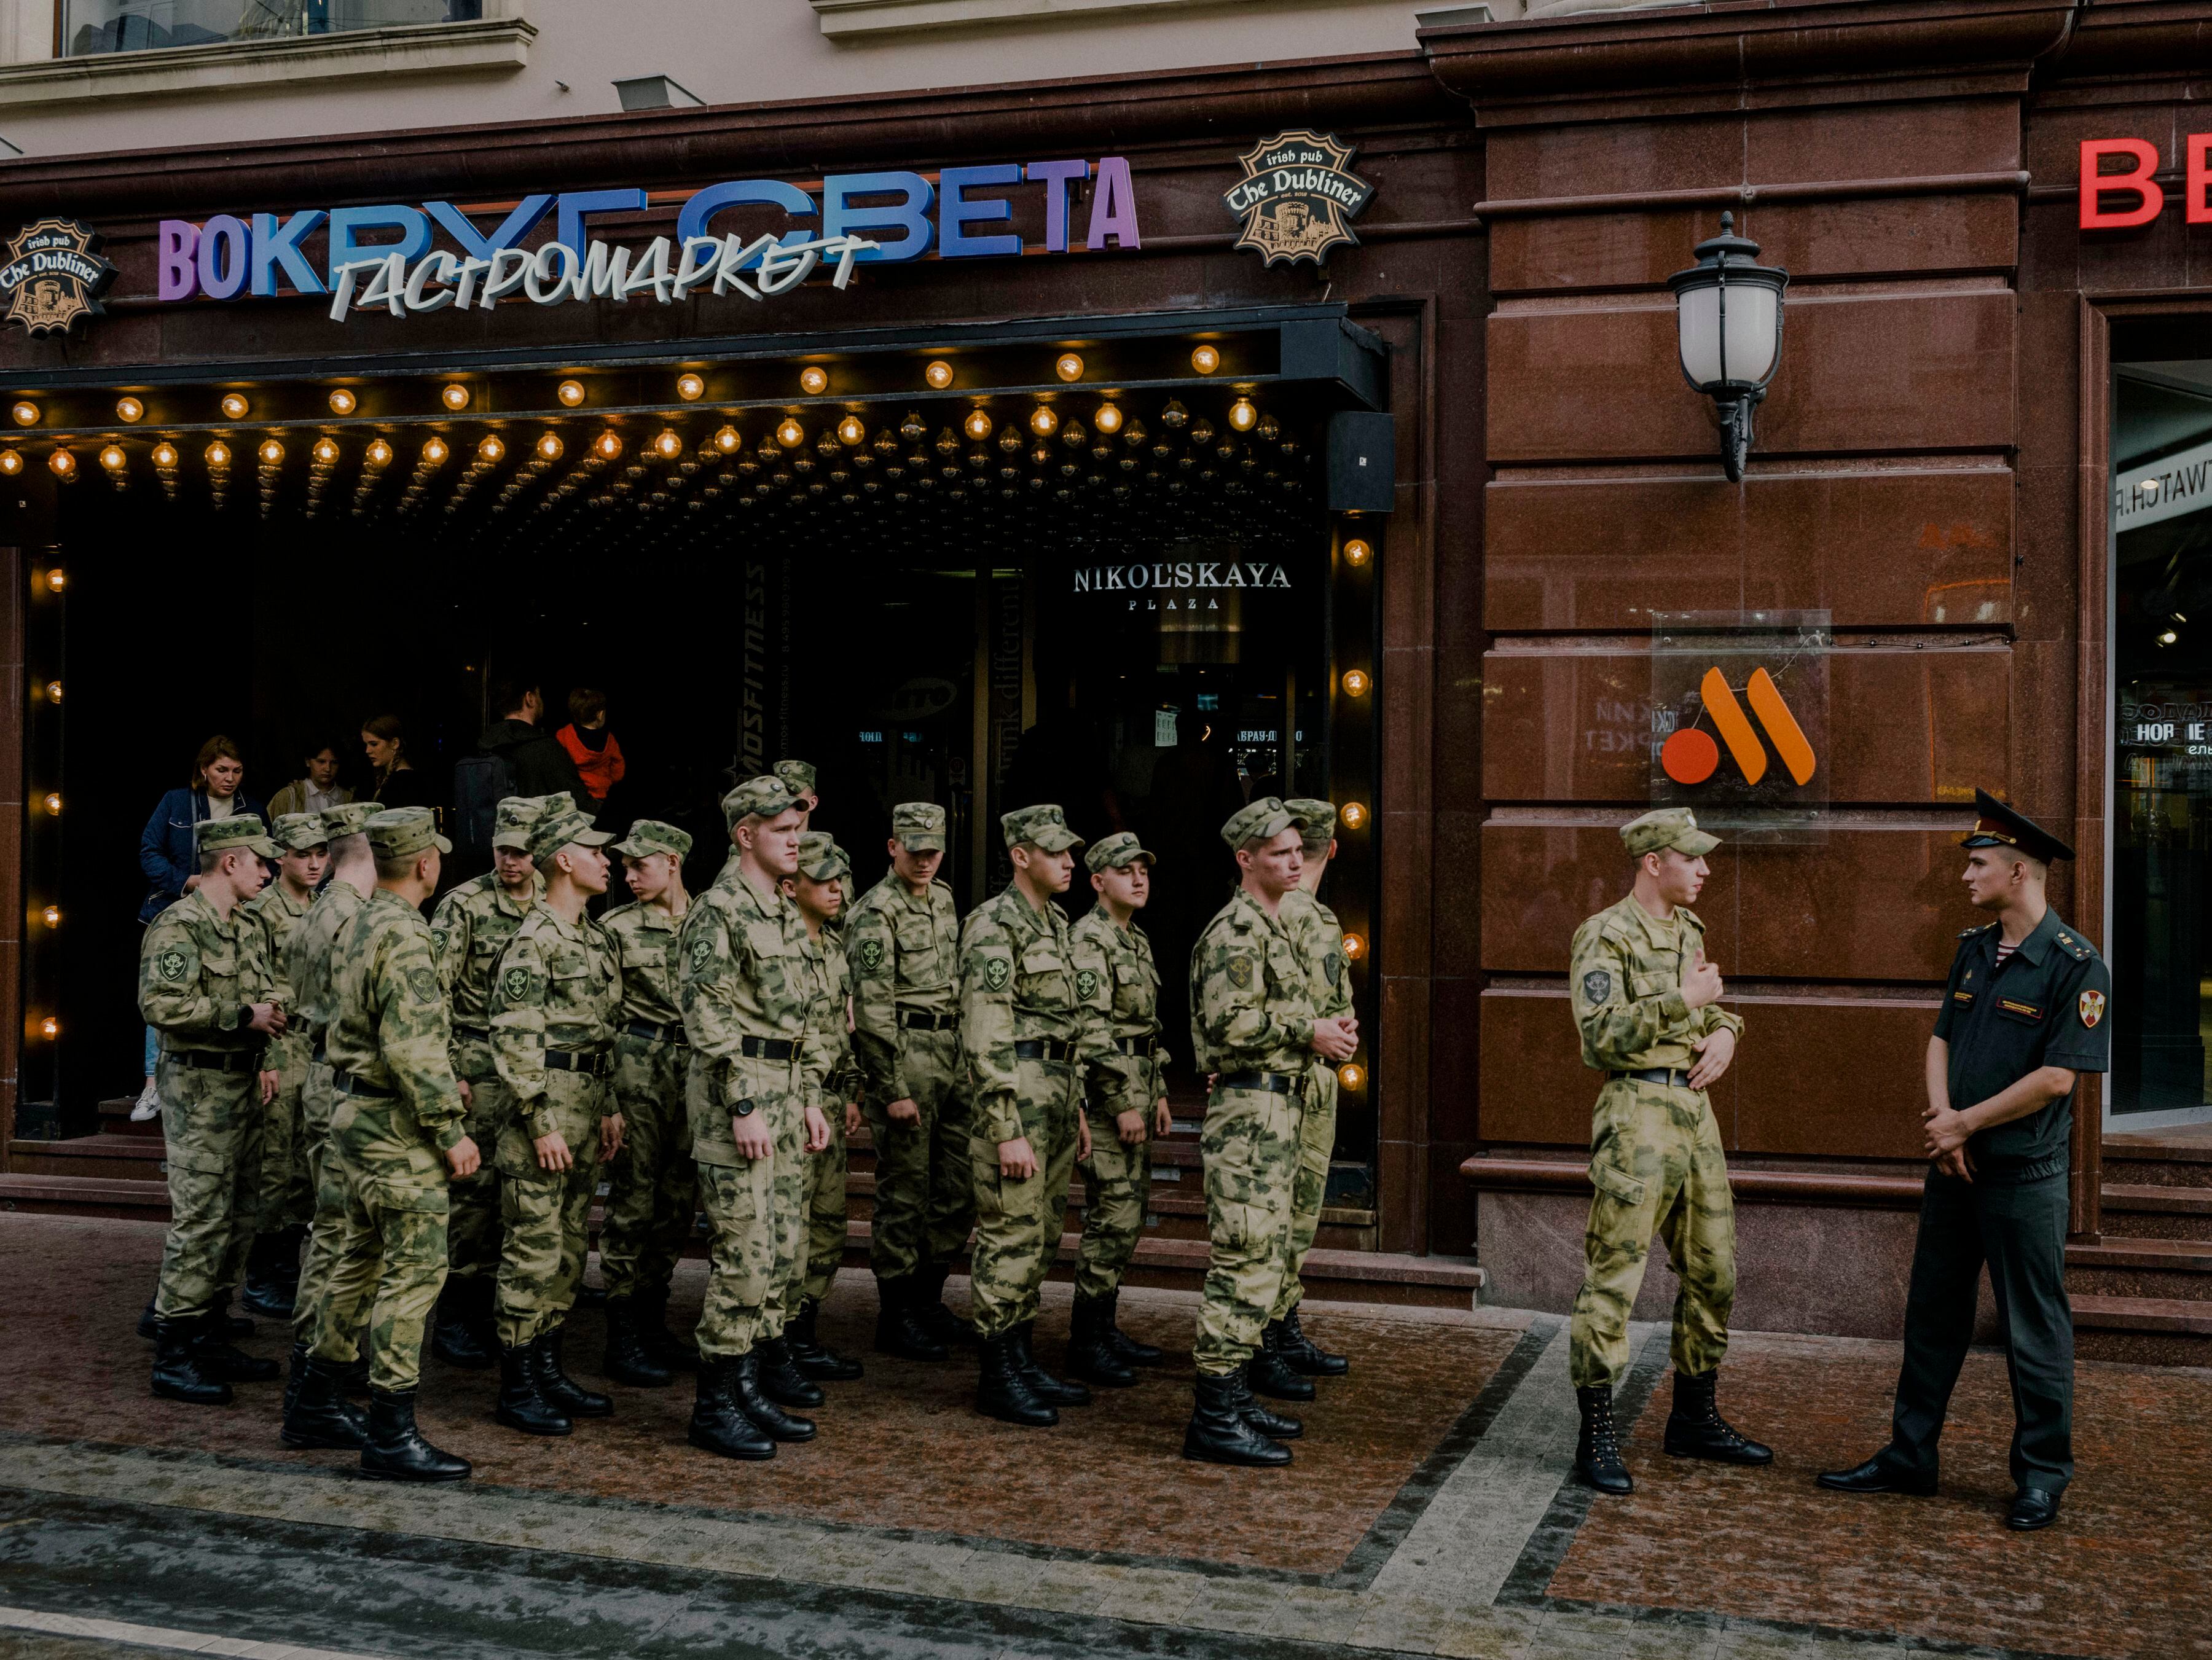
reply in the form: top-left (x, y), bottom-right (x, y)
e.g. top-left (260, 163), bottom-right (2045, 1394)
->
top-left (969, 1061), bottom-right (1084, 1337)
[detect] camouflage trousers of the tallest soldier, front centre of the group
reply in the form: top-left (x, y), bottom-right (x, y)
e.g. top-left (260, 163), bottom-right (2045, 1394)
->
top-left (690, 1061), bottom-right (807, 1360)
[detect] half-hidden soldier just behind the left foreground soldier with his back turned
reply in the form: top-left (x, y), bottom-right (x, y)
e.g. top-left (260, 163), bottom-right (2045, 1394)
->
top-left (429, 791), bottom-right (553, 1368)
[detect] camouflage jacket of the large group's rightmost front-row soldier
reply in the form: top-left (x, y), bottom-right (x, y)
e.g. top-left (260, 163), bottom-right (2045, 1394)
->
top-left (1190, 888), bottom-right (1316, 1076)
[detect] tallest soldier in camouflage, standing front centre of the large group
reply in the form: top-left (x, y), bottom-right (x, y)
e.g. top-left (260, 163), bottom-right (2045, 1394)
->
top-left (679, 776), bottom-right (830, 1459)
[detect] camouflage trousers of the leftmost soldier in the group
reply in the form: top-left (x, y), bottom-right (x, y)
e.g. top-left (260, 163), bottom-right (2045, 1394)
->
top-left (152, 1050), bottom-right (263, 1320)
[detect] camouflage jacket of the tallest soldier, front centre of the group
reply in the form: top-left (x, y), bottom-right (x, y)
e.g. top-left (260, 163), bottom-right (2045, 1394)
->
top-left (679, 860), bottom-right (810, 1105)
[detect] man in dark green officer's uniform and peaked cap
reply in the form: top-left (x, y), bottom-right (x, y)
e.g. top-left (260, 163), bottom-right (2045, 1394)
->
top-left (1821, 791), bottom-right (2112, 1532)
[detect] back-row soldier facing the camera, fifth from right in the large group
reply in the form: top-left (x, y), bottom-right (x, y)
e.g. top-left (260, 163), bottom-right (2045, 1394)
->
top-left (845, 800), bottom-right (976, 1360)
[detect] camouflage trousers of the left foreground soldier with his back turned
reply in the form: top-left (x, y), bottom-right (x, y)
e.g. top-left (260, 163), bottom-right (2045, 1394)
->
top-left (310, 1154), bottom-right (447, 1393)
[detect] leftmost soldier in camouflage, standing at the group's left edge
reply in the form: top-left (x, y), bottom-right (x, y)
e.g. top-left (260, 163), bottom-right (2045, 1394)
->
top-left (139, 813), bottom-right (285, 1406)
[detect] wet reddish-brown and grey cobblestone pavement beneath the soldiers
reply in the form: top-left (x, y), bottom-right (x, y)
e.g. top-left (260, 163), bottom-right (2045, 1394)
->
top-left (0, 1216), bottom-right (2212, 1660)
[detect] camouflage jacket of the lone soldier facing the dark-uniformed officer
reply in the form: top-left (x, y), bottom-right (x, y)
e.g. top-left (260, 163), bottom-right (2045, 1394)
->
top-left (1566, 893), bottom-right (1743, 1072)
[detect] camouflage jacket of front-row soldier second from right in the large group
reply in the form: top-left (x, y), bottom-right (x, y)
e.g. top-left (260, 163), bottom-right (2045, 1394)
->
top-left (960, 884), bottom-right (1113, 1141)
